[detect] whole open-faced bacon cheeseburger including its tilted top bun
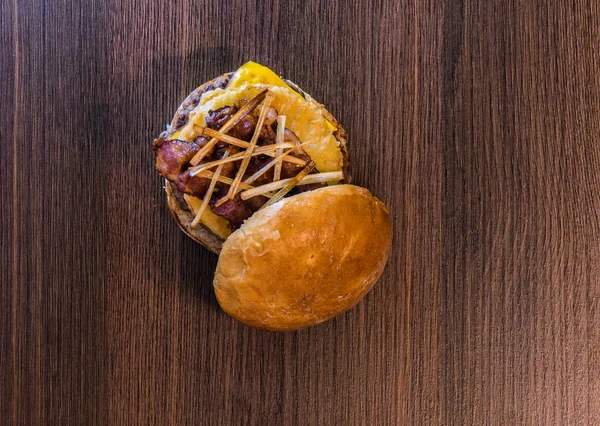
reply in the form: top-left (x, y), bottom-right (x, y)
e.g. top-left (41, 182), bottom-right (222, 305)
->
top-left (154, 62), bottom-right (392, 331)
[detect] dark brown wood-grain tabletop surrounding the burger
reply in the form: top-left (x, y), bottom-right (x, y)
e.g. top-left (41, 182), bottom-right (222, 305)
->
top-left (0, 0), bottom-right (600, 425)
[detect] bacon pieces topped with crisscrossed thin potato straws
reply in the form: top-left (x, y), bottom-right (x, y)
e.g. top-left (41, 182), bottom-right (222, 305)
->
top-left (154, 89), bottom-right (344, 229)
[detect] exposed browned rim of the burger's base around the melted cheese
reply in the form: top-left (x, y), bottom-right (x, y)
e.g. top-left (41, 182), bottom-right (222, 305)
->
top-left (159, 73), bottom-right (349, 254)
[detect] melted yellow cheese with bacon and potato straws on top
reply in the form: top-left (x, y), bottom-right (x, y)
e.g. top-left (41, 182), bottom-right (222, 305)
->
top-left (154, 63), bottom-right (344, 238)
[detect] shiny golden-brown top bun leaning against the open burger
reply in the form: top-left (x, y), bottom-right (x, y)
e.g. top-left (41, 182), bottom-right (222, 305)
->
top-left (214, 185), bottom-right (392, 331)
